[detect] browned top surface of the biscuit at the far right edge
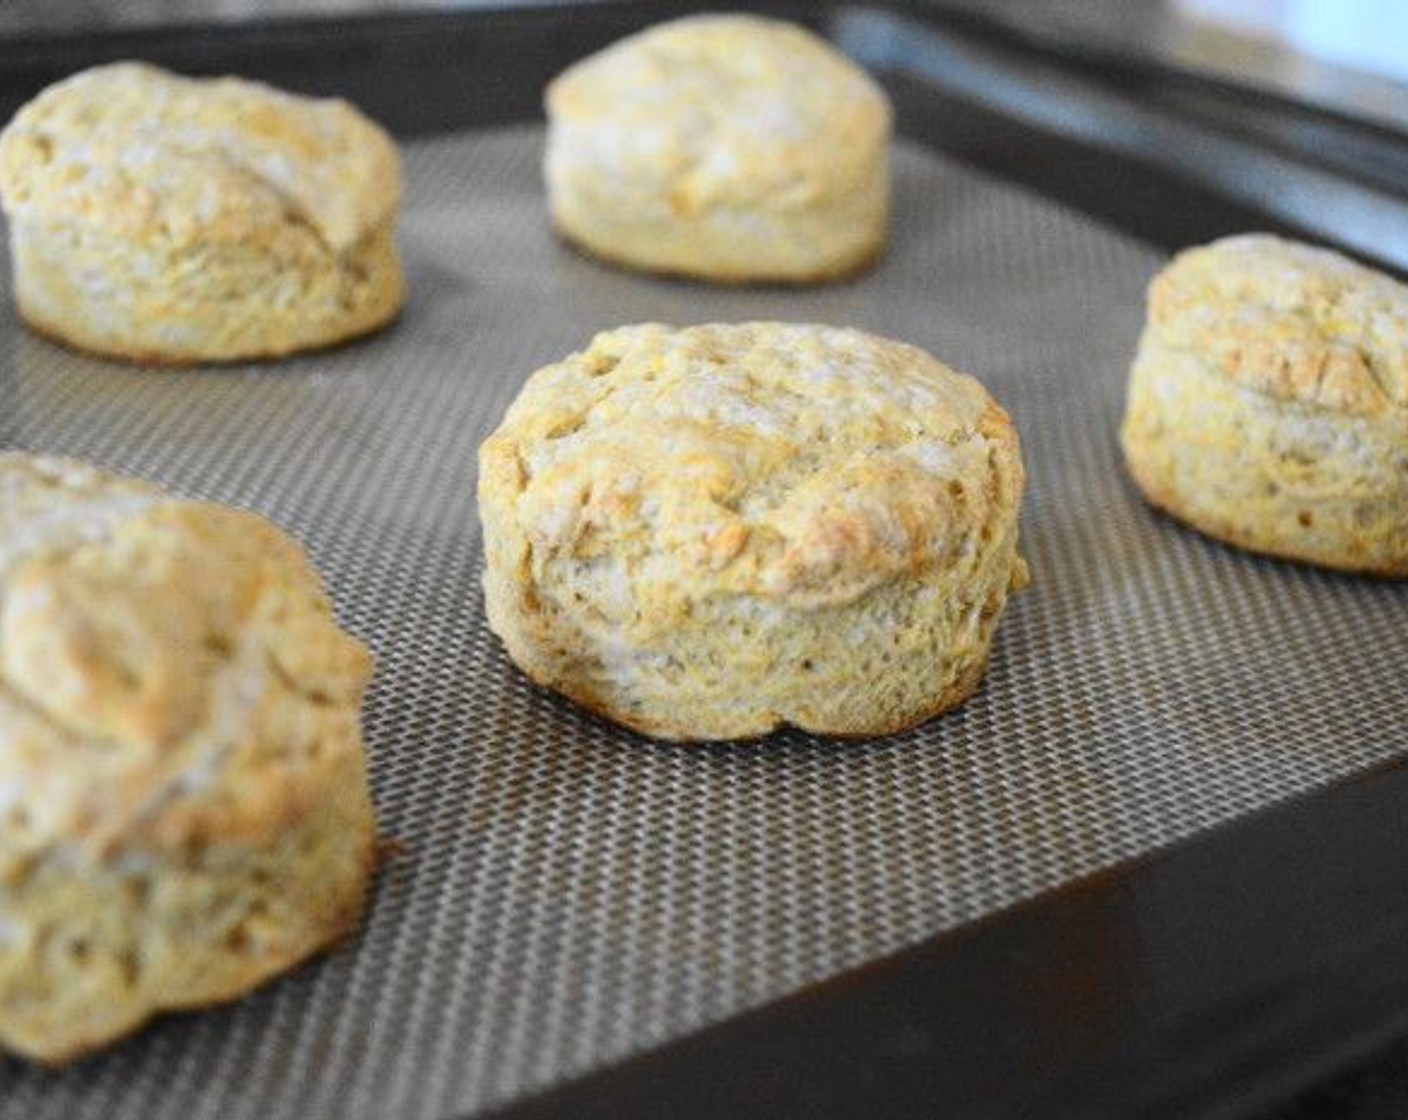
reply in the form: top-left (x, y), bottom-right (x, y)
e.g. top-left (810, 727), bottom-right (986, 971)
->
top-left (1149, 234), bottom-right (1408, 418)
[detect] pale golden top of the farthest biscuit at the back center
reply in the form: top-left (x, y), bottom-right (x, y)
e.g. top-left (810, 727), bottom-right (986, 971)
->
top-left (546, 15), bottom-right (891, 213)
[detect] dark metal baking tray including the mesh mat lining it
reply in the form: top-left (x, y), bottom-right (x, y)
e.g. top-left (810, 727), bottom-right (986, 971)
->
top-left (0, 3), bottom-right (1408, 1119)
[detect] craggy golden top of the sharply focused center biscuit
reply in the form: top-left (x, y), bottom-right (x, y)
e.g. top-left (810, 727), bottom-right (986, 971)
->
top-left (480, 323), bottom-right (1022, 622)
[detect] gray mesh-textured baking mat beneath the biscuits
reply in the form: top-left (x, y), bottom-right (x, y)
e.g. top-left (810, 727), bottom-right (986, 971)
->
top-left (0, 128), bottom-right (1408, 1120)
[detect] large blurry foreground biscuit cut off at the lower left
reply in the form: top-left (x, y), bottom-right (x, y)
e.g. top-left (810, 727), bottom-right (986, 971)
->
top-left (0, 454), bottom-right (373, 1062)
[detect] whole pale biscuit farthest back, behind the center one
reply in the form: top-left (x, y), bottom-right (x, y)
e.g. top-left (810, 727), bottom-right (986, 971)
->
top-left (543, 15), bottom-right (891, 283)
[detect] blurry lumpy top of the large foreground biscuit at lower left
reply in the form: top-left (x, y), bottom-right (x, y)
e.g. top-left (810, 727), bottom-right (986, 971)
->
top-left (0, 454), bottom-right (370, 855)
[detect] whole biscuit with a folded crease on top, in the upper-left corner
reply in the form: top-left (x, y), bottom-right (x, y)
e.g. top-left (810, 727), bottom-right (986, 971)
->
top-left (0, 62), bottom-right (403, 365)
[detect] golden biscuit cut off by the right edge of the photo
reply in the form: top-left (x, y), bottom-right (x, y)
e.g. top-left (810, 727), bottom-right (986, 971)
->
top-left (1121, 234), bottom-right (1408, 578)
